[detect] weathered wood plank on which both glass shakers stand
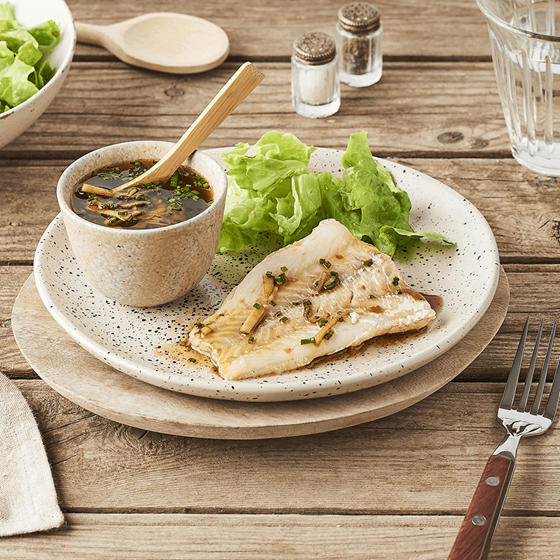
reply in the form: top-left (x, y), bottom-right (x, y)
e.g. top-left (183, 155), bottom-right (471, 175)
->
top-left (0, 62), bottom-right (509, 160)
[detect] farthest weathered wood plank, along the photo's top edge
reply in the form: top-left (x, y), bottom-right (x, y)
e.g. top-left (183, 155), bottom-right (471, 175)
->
top-left (68, 0), bottom-right (490, 59)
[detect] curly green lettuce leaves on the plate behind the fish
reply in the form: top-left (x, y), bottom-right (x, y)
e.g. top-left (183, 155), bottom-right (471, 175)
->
top-left (218, 131), bottom-right (451, 256)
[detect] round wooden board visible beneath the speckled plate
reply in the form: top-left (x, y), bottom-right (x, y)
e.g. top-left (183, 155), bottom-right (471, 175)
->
top-left (12, 269), bottom-right (509, 439)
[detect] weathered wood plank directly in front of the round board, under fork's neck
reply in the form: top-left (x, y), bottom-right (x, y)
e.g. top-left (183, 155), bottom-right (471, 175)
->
top-left (8, 380), bottom-right (560, 516)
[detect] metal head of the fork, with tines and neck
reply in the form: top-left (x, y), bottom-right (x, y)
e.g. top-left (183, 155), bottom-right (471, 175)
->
top-left (494, 317), bottom-right (560, 458)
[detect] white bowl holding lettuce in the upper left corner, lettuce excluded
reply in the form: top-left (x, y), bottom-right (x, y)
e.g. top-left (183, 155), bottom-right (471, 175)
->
top-left (0, 0), bottom-right (76, 148)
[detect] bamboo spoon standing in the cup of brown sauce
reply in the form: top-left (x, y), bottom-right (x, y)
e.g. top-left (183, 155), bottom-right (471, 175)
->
top-left (81, 62), bottom-right (264, 196)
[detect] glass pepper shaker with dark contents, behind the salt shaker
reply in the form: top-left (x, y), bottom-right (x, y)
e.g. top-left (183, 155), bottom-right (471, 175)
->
top-left (336, 2), bottom-right (383, 87)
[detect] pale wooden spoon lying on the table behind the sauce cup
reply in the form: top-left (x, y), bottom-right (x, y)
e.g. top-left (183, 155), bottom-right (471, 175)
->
top-left (75, 12), bottom-right (229, 74)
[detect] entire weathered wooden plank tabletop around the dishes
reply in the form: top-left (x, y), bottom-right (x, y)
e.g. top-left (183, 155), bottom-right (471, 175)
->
top-left (0, 0), bottom-right (560, 560)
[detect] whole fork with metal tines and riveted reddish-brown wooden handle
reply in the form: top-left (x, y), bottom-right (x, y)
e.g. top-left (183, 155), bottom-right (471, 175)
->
top-left (448, 317), bottom-right (560, 560)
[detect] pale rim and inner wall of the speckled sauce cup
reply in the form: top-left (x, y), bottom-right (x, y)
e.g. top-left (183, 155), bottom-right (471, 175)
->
top-left (56, 140), bottom-right (227, 238)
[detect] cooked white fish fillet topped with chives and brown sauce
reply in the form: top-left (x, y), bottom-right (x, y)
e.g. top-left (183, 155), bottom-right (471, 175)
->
top-left (189, 219), bottom-right (435, 380)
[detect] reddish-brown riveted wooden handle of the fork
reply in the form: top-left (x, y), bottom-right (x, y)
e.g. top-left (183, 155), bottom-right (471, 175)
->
top-left (448, 455), bottom-right (515, 560)
